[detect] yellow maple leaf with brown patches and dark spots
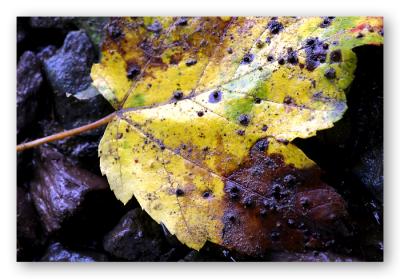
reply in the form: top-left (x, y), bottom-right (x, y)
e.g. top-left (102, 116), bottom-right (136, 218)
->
top-left (91, 17), bottom-right (383, 254)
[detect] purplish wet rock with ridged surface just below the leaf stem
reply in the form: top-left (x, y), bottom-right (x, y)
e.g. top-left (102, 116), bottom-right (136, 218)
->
top-left (31, 146), bottom-right (108, 233)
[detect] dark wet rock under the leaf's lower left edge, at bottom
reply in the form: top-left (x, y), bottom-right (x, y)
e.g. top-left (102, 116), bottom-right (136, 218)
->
top-left (104, 208), bottom-right (163, 261)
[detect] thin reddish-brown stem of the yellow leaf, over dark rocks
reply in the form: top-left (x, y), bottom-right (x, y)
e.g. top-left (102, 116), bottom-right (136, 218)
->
top-left (17, 112), bottom-right (116, 152)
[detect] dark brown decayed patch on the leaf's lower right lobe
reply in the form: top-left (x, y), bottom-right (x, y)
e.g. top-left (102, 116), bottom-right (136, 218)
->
top-left (223, 139), bottom-right (347, 255)
